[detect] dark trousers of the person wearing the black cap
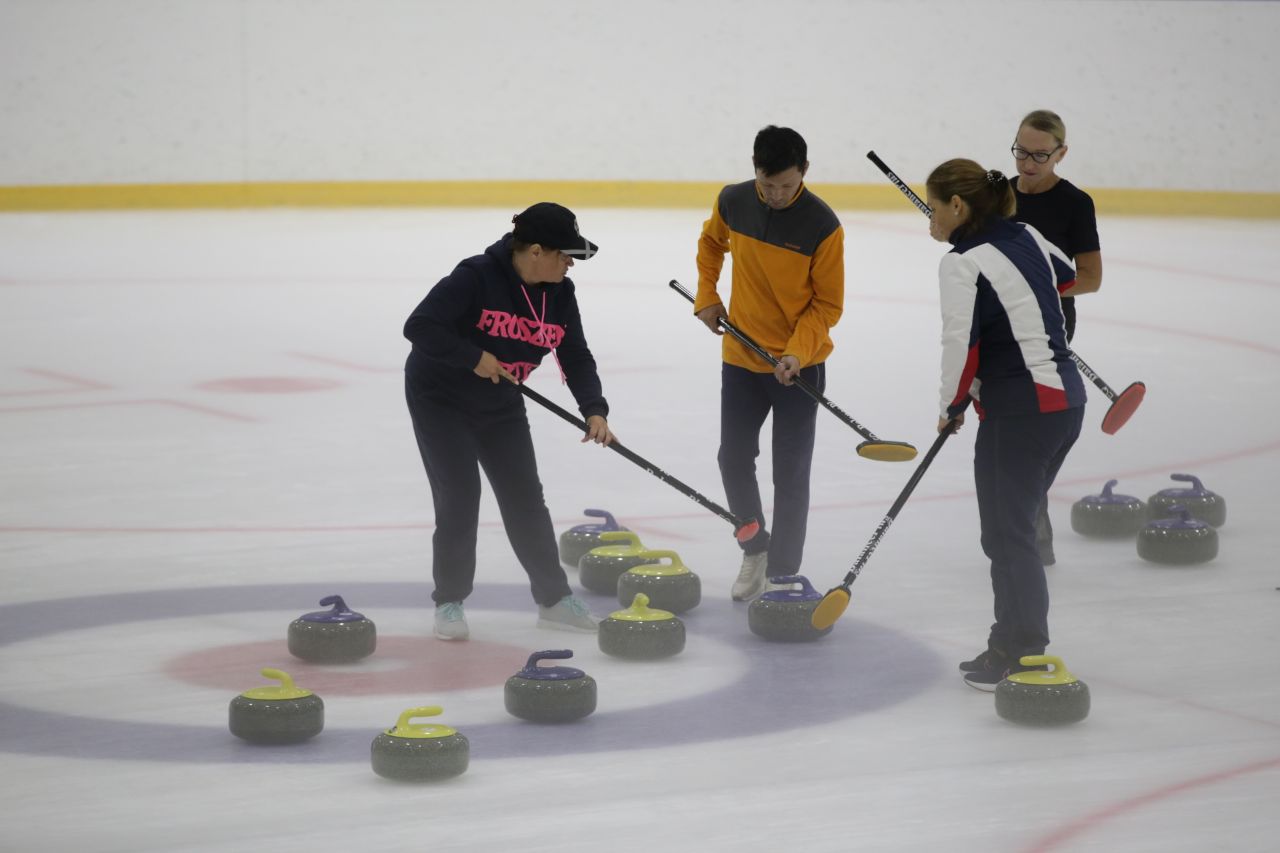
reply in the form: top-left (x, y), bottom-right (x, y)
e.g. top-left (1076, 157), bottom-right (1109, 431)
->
top-left (404, 380), bottom-right (571, 607)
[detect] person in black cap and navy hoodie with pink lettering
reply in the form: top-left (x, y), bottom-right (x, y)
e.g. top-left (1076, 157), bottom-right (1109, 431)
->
top-left (404, 202), bottom-right (613, 639)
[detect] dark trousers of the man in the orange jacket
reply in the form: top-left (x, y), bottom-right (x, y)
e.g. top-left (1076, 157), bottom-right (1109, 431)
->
top-left (718, 364), bottom-right (827, 576)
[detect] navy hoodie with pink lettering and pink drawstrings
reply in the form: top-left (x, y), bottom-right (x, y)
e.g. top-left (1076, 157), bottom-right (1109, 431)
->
top-left (404, 234), bottom-right (609, 419)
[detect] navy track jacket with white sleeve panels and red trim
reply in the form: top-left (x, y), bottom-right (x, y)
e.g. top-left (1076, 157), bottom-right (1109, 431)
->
top-left (938, 219), bottom-right (1084, 418)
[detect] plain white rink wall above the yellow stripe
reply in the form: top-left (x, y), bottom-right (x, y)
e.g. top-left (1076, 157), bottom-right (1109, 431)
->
top-left (0, 0), bottom-right (1280, 192)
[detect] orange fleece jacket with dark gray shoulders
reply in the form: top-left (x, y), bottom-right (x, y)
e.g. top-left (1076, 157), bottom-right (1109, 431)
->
top-left (694, 181), bottom-right (845, 373)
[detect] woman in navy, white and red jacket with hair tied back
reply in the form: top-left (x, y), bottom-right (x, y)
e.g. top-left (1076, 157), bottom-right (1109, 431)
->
top-left (925, 160), bottom-right (1084, 690)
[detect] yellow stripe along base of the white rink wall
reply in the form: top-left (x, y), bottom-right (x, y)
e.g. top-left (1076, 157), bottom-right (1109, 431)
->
top-left (0, 181), bottom-right (1280, 219)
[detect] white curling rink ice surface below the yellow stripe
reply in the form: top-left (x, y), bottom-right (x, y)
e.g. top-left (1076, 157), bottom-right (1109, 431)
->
top-left (0, 207), bottom-right (1280, 853)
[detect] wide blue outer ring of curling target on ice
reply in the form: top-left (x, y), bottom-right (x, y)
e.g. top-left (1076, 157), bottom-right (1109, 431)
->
top-left (0, 583), bottom-right (941, 763)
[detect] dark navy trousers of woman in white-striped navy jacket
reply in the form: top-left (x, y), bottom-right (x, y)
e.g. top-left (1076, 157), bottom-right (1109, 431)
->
top-left (973, 406), bottom-right (1084, 661)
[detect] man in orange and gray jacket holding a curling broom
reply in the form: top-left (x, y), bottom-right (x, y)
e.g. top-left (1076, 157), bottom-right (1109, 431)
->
top-left (694, 124), bottom-right (845, 601)
